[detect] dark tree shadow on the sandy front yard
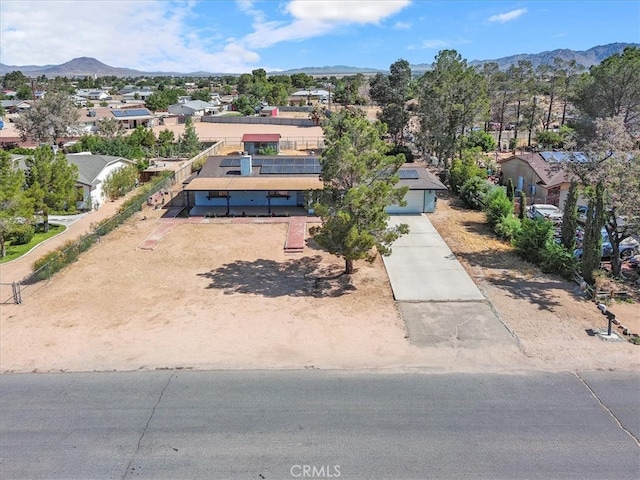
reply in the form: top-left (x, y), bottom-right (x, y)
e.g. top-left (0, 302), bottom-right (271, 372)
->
top-left (198, 255), bottom-right (356, 298)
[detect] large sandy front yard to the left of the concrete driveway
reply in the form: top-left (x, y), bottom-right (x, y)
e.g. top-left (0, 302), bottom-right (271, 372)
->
top-left (0, 206), bottom-right (504, 372)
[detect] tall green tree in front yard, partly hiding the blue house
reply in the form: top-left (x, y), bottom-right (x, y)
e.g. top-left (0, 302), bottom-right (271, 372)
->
top-left (311, 110), bottom-right (408, 274)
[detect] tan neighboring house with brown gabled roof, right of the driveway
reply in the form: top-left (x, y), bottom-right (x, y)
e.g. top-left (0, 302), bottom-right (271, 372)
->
top-left (498, 152), bottom-right (586, 210)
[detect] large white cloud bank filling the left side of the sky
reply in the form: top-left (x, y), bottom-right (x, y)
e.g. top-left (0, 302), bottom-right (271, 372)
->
top-left (0, 0), bottom-right (410, 73)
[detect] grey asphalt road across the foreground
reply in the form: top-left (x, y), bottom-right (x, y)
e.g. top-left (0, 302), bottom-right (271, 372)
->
top-left (0, 370), bottom-right (640, 480)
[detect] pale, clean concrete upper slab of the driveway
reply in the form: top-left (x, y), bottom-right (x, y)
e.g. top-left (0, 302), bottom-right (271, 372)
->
top-left (383, 215), bottom-right (485, 302)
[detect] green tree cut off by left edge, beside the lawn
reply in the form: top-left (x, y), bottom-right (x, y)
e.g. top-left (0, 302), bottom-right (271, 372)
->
top-left (0, 150), bottom-right (33, 258)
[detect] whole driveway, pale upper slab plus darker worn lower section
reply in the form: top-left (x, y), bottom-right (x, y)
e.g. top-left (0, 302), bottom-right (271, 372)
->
top-left (383, 215), bottom-right (524, 350)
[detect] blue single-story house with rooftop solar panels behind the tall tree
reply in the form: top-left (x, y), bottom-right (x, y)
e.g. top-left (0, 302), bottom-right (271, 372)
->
top-left (183, 155), bottom-right (447, 216)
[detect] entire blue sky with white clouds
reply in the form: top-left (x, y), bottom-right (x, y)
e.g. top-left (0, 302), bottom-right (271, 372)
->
top-left (0, 0), bottom-right (640, 73)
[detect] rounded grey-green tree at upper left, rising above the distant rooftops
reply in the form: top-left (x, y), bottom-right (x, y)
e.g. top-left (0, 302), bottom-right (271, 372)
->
top-left (16, 92), bottom-right (81, 144)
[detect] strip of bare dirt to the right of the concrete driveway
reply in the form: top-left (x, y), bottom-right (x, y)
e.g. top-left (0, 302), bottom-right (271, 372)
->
top-left (430, 192), bottom-right (640, 370)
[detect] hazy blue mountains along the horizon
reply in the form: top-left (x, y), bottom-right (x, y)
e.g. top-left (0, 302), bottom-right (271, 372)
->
top-left (0, 43), bottom-right (640, 77)
